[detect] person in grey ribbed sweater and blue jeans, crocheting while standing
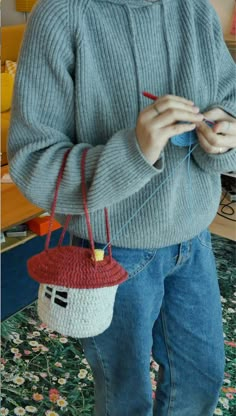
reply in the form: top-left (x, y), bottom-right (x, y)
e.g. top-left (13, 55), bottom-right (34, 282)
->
top-left (8, 0), bottom-right (236, 416)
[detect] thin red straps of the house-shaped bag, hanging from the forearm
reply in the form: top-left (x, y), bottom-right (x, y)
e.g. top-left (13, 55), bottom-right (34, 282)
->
top-left (45, 148), bottom-right (112, 264)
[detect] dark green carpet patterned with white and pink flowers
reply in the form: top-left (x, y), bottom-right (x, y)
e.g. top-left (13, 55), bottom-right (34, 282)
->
top-left (0, 235), bottom-right (236, 416)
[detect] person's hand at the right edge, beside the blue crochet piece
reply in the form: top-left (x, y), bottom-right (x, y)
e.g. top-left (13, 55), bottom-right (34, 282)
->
top-left (196, 108), bottom-right (236, 154)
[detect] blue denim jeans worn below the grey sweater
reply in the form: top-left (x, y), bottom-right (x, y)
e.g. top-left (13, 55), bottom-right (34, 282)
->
top-left (73, 231), bottom-right (225, 416)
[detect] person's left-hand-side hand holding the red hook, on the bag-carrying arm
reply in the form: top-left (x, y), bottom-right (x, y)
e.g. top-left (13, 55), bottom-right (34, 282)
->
top-left (135, 95), bottom-right (203, 165)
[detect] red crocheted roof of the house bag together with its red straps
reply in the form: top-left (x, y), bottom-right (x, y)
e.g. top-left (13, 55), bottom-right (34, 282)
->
top-left (27, 149), bottom-right (128, 289)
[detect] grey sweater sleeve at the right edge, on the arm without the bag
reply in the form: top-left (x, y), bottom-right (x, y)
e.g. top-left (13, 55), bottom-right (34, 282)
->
top-left (193, 6), bottom-right (236, 173)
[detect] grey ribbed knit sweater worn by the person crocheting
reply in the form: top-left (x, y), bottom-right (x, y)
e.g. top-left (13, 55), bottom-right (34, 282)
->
top-left (8, 0), bottom-right (236, 248)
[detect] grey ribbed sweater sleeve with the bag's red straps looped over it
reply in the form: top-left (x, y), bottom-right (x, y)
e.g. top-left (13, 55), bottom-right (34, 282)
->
top-left (8, 0), bottom-right (163, 215)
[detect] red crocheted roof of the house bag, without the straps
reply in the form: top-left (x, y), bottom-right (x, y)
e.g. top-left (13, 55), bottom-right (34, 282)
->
top-left (27, 246), bottom-right (128, 289)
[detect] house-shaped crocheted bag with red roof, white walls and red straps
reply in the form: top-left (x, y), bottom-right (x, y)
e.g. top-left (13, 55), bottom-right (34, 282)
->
top-left (27, 149), bottom-right (128, 338)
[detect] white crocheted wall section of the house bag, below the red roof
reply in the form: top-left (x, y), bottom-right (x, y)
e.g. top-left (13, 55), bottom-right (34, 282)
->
top-left (38, 285), bottom-right (118, 338)
